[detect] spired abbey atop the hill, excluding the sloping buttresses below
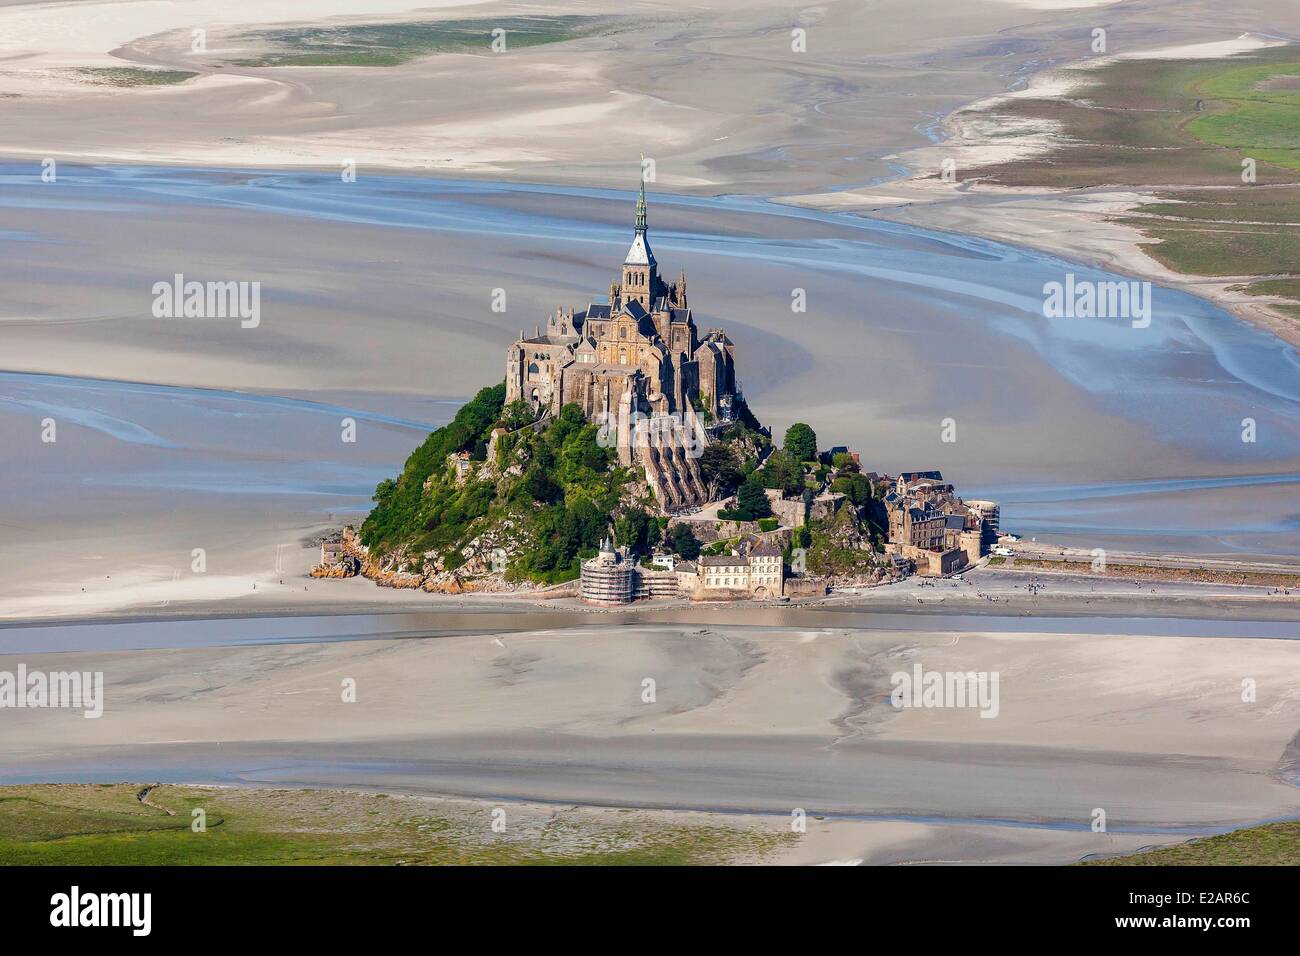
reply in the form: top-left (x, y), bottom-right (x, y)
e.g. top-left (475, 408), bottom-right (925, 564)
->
top-left (506, 181), bottom-right (737, 423)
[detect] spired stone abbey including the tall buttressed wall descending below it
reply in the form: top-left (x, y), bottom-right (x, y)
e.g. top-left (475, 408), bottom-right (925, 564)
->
top-left (506, 174), bottom-right (740, 511)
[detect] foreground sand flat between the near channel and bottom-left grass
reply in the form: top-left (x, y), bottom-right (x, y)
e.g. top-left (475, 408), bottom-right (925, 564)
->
top-left (0, 624), bottom-right (1300, 862)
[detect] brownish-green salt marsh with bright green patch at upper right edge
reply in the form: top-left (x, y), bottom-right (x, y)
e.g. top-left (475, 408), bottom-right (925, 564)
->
top-left (966, 47), bottom-right (1300, 316)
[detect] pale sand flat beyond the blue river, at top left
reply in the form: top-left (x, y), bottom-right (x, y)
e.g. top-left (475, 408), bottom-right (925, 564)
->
top-left (0, 0), bottom-right (1107, 194)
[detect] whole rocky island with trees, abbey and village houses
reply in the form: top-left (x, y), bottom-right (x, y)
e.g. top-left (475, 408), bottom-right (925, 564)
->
top-left (322, 178), bottom-right (997, 605)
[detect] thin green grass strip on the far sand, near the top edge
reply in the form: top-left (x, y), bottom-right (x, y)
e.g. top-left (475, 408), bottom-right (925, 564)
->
top-left (233, 16), bottom-right (616, 66)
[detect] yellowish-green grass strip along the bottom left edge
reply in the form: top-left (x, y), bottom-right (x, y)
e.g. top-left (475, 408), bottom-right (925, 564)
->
top-left (0, 784), bottom-right (794, 866)
